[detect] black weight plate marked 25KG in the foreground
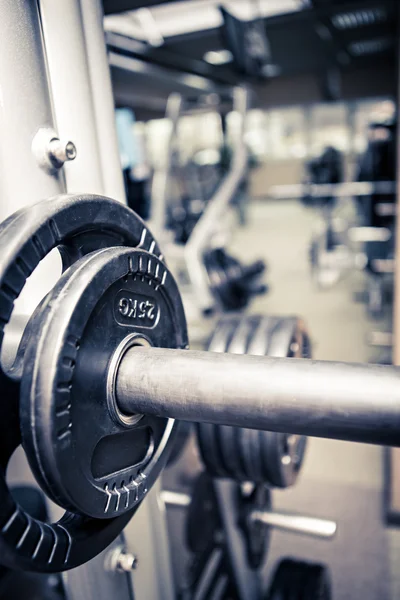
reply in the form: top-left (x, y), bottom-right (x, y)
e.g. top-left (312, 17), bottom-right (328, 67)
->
top-left (20, 248), bottom-right (188, 519)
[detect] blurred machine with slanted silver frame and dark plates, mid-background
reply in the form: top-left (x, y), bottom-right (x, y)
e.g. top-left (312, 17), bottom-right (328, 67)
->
top-left (150, 88), bottom-right (267, 320)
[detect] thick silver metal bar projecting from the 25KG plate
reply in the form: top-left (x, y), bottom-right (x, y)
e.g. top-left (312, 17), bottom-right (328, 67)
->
top-left (116, 348), bottom-right (400, 446)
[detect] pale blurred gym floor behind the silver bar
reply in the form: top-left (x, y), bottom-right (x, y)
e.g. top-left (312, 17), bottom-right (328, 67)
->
top-left (231, 200), bottom-right (400, 600)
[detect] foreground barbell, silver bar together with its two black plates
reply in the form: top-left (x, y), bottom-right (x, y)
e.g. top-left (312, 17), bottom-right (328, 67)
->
top-left (0, 195), bottom-right (400, 572)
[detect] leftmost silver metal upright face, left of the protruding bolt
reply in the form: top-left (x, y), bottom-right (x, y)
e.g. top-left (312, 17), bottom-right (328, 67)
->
top-left (0, 0), bottom-right (65, 220)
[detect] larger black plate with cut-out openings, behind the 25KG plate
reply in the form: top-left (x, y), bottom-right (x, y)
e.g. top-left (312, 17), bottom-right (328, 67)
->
top-left (0, 195), bottom-right (164, 572)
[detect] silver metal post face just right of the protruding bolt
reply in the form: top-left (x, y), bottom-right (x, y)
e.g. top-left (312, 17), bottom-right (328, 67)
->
top-left (38, 0), bottom-right (105, 194)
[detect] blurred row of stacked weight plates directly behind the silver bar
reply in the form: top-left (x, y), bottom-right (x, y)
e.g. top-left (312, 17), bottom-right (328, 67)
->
top-left (197, 315), bottom-right (311, 488)
